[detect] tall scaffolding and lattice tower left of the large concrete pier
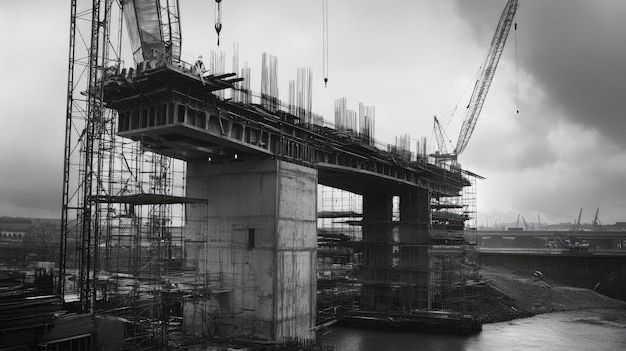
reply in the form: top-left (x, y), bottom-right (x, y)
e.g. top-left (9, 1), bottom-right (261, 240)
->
top-left (56, 0), bottom-right (212, 350)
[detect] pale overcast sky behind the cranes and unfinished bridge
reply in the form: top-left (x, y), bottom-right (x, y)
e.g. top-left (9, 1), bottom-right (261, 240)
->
top-left (0, 0), bottom-right (626, 224)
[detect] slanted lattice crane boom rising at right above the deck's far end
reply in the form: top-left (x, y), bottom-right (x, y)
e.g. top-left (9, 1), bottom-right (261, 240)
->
top-left (454, 0), bottom-right (519, 156)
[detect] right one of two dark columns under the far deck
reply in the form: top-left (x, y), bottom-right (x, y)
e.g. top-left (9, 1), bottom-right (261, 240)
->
top-left (398, 188), bottom-right (430, 311)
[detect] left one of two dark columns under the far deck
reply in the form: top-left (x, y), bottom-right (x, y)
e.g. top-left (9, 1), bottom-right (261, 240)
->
top-left (361, 188), bottom-right (393, 310)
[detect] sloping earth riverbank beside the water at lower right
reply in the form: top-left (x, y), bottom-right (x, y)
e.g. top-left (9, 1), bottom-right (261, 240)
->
top-left (475, 266), bottom-right (626, 323)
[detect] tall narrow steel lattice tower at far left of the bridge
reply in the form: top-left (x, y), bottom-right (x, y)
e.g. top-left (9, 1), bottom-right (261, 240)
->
top-left (58, 0), bottom-right (120, 312)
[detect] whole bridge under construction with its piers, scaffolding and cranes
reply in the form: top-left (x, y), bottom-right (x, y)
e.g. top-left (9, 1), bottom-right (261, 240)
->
top-left (14, 0), bottom-right (517, 350)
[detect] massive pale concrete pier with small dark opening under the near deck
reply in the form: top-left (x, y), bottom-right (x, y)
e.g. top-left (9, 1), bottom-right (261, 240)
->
top-left (186, 159), bottom-right (317, 341)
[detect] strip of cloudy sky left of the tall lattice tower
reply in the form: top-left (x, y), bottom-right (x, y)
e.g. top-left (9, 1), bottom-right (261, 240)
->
top-left (0, 1), bottom-right (69, 217)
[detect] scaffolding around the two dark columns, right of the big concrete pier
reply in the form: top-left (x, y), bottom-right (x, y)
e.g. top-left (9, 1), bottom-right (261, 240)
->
top-left (318, 160), bottom-right (479, 323)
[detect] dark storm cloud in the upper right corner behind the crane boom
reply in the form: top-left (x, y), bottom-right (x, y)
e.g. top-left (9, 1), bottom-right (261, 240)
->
top-left (456, 0), bottom-right (626, 147)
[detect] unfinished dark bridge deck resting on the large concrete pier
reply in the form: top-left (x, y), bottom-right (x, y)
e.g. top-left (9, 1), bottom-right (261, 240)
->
top-left (104, 65), bottom-right (470, 196)
